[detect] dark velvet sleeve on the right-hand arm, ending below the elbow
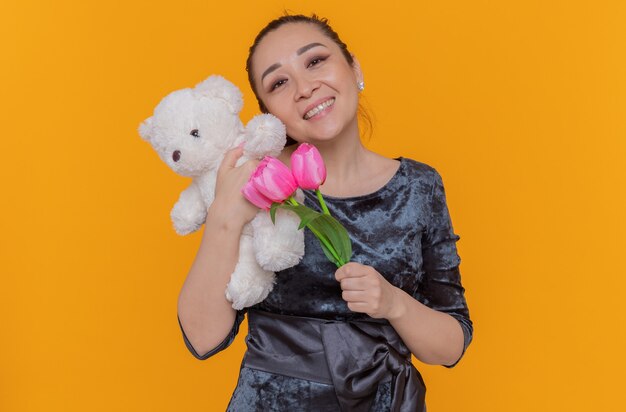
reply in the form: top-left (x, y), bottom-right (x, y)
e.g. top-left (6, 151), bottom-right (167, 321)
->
top-left (414, 169), bottom-right (474, 368)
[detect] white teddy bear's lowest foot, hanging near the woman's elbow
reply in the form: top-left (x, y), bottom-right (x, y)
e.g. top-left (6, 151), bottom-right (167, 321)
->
top-left (226, 262), bottom-right (276, 310)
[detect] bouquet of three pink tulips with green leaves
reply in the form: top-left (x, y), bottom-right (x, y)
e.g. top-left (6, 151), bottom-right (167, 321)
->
top-left (241, 143), bottom-right (352, 267)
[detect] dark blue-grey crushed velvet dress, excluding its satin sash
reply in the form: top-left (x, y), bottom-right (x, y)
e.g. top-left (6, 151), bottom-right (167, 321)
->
top-left (181, 157), bottom-right (473, 412)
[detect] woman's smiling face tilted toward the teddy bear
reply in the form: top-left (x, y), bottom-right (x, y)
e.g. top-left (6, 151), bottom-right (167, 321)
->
top-left (252, 23), bottom-right (362, 144)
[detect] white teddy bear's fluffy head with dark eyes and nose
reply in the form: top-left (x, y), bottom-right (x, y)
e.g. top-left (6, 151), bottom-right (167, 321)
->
top-left (139, 76), bottom-right (244, 177)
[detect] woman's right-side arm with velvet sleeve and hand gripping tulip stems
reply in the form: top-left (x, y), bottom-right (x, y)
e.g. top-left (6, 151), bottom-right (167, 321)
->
top-left (336, 169), bottom-right (473, 367)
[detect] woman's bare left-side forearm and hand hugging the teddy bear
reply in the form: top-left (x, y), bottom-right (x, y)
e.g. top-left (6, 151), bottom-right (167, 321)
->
top-left (178, 148), bottom-right (258, 354)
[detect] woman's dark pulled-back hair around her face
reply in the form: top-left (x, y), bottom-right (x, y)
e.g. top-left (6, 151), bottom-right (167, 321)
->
top-left (246, 13), bottom-right (372, 146)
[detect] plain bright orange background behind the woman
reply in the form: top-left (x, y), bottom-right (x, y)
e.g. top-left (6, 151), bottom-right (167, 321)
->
top-left (0, 0), bottom-right (626, 412)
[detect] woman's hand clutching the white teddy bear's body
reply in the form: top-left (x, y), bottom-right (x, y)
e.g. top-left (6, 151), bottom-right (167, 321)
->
top-left (210, 147), bottom-right (259, 226)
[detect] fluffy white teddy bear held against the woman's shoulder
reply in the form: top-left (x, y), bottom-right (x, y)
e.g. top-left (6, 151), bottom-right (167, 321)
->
top-left (139, 76), bottom-right (304, 309)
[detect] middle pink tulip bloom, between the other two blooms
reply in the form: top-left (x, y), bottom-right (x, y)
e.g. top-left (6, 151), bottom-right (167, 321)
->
top-left (250, 156), bottom-right (298, 203)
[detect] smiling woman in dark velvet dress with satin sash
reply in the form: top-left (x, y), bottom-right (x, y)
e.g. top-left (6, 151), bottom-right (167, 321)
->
top-left (178, 15), bottom-right (473, 411)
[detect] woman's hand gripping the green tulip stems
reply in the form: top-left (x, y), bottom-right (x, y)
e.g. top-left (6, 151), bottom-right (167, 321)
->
top-left (335, 262), bottom-right (402, 319)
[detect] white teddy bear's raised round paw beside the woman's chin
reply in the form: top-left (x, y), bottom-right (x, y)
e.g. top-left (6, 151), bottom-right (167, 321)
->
top-left (245, 114), bottom-right (287, 159)
